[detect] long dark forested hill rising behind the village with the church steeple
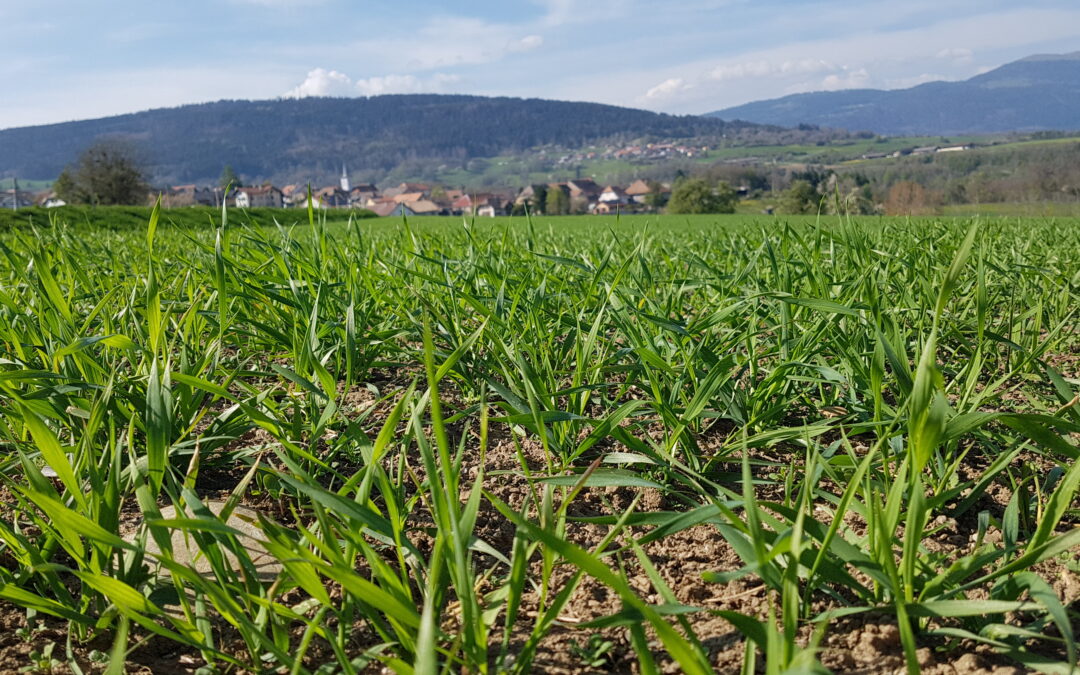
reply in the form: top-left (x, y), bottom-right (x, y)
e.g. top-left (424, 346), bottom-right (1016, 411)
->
top-left (0, 94), bottom-right (783, 184)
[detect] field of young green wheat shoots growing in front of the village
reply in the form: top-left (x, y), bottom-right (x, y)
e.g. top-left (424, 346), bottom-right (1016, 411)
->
top-left (0, 211), bottom-right (1080, 675)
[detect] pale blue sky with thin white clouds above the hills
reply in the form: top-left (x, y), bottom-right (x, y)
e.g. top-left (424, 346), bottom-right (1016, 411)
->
top-left (0, 0), bottom-right (1080, 129)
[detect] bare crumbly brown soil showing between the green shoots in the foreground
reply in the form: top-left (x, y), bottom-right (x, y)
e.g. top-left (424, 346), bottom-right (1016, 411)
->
top-left (0, 362), bottom-right (1080, 675)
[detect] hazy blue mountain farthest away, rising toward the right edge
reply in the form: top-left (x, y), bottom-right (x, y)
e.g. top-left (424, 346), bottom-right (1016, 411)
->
top-left (707, 52), bottom-right (1080, 136)
